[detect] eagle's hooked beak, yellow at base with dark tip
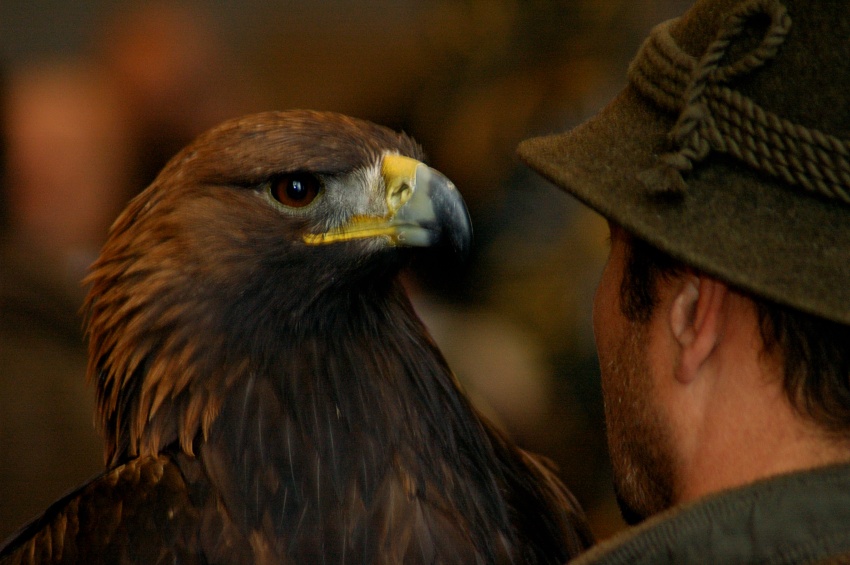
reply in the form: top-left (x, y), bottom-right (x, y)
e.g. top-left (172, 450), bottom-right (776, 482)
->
top-left (304, 155), bottom-right (472, 257)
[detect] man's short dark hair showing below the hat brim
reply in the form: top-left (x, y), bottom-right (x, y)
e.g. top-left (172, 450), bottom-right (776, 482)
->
top-left (620, 235), bottom-right (850, 436)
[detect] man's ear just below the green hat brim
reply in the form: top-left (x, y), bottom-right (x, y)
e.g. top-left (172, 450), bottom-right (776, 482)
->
top-left (669, 273), bottom-right (728, 382)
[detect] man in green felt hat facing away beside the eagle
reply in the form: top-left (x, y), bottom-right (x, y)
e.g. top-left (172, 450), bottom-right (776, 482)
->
top-left (519, 0), bottom-right (850, 563)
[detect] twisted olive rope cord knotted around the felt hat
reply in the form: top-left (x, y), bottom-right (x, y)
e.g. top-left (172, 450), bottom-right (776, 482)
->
top-left (629, 0), bottom-right (850, 203)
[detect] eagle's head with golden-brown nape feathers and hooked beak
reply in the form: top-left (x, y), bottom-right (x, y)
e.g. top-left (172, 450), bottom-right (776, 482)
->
top-left (84, 111), bottom-right (471, 464)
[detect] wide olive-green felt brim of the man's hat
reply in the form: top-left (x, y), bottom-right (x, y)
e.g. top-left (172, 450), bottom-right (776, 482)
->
top-left (517, 86), bottom-right (850, 324)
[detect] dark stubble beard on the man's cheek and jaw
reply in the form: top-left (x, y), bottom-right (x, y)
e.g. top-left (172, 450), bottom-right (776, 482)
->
top-left (602, 323), bottom-right (675, 524)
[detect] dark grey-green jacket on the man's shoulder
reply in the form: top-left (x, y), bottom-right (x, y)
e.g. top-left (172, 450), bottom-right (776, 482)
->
top-left (571, 465), bottom-right (850, 565)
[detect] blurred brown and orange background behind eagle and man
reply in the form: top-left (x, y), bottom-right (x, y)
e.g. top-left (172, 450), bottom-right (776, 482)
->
top-left (0, 0), bottom-right (689, 538)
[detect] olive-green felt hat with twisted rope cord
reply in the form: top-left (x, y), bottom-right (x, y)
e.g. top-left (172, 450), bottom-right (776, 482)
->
top-left (518, 0), bottom-right (850, 324)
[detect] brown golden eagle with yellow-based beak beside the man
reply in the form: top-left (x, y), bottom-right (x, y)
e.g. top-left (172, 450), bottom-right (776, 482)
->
top-left (0, 111), bottom-right (590, 564)
